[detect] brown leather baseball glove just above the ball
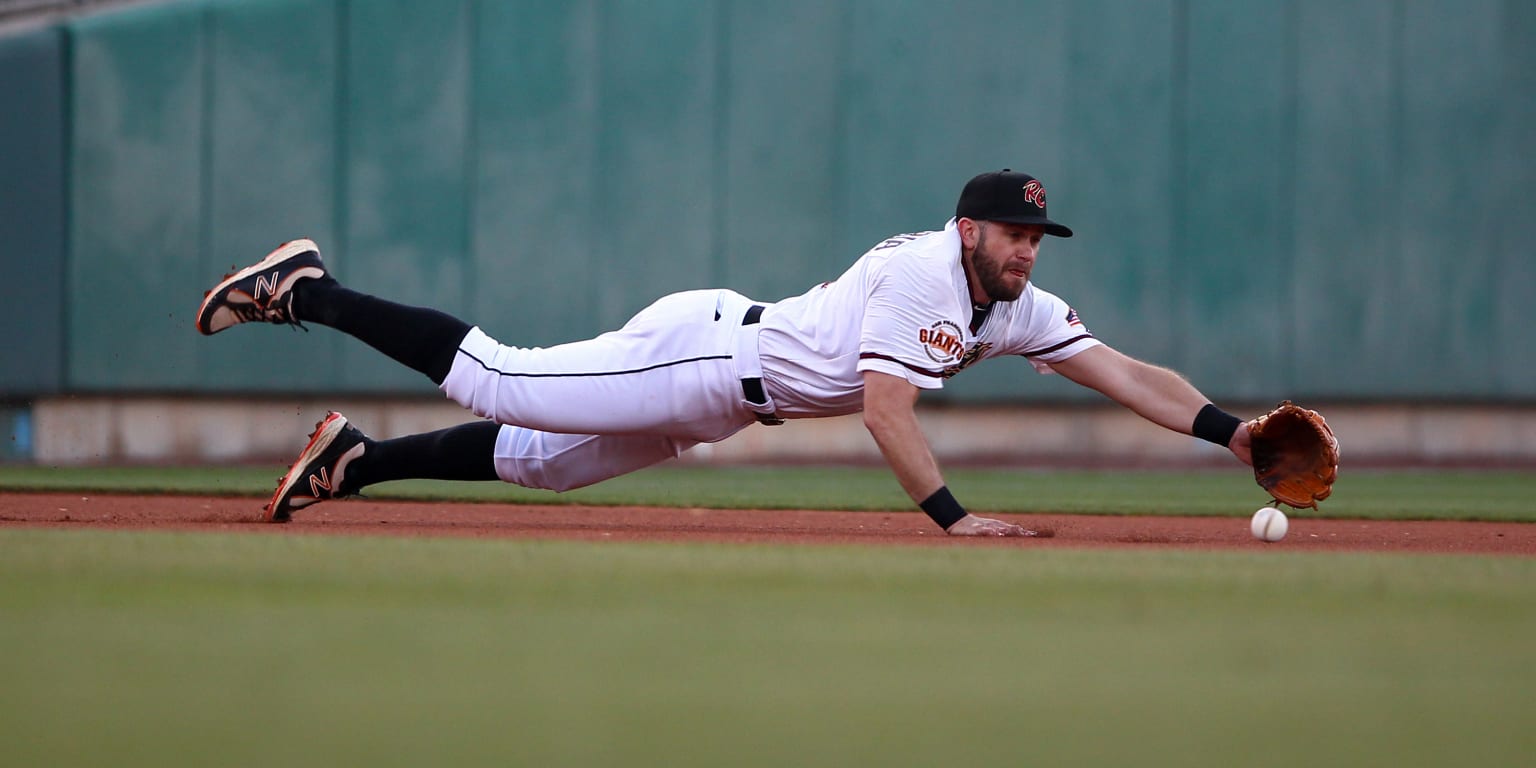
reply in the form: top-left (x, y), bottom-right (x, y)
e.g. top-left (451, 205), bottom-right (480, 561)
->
top-left (1249, 399), bottom-right (1339, 510)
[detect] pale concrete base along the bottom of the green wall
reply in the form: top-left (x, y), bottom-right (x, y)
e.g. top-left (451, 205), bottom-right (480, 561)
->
top-left (21, 396), bottom-right (1536, 467)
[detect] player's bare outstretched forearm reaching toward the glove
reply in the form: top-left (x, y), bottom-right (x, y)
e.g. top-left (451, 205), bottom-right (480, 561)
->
top-left (1051, 346), bottom-right (1253, 464)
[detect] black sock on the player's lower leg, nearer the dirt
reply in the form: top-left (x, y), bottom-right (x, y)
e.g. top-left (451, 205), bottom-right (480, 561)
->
top-left (346, 421), bottom-right (501, 493)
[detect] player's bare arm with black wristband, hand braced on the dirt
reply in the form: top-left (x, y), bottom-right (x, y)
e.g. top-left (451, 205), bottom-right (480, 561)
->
top-left (863, 370), bottom-right (1032, 536)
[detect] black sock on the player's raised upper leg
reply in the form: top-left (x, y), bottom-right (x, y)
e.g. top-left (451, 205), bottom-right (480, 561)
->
top-left (293, 276), bottom-right (470, 384)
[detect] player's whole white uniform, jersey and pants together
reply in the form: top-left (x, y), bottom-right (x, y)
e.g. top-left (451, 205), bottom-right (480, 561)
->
top-left (441, 220), bottom-right (1098, 490)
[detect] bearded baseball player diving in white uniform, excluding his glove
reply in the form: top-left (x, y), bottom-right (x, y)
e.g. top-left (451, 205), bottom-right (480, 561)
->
top-left (197, 169), bottom-right (1252, 536)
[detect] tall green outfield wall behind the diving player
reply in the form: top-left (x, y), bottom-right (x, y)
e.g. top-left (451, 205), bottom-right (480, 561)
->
top-left (0, 0), bottom-right (1536, 402)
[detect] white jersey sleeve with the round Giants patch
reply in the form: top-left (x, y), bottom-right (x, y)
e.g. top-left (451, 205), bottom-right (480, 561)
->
top-left (857, 252), bottom-right (965, 389)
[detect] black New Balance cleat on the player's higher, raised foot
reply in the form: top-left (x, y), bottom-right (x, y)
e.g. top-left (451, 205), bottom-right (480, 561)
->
top-left (197, 238), bottom-right (326, 336)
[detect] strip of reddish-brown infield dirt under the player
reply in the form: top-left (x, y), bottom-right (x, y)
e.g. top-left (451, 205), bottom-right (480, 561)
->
top-left (0, 493), bottom-right (1536, 556)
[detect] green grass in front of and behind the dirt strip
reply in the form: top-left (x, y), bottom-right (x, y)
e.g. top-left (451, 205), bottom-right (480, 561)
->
top-left (0, 468), bottom-right (1536, 766)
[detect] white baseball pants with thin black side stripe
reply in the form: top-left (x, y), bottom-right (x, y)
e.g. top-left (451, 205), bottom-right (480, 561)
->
top-left (441, 290), bottom-right (773, 490)
